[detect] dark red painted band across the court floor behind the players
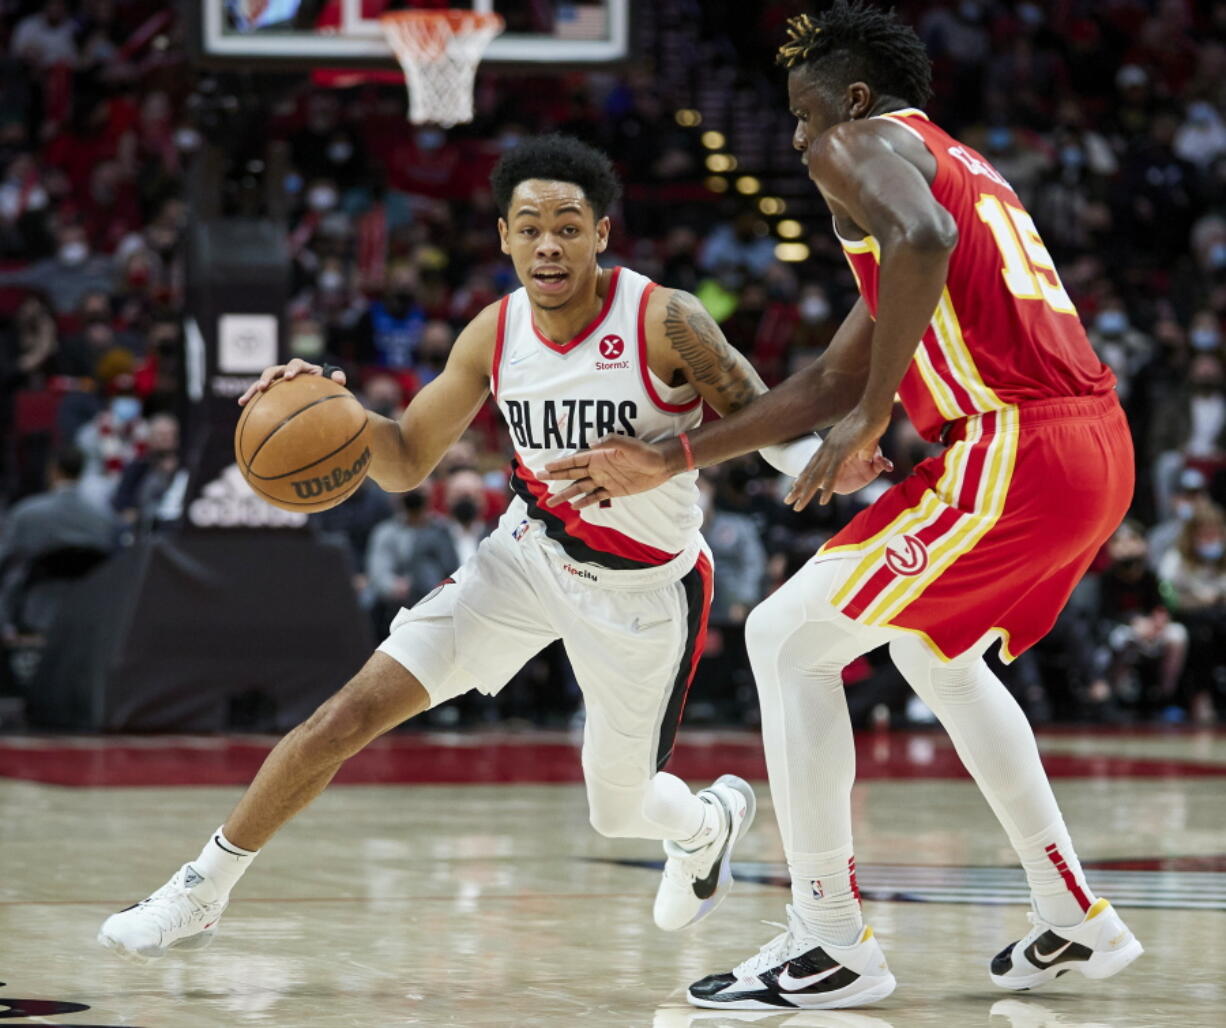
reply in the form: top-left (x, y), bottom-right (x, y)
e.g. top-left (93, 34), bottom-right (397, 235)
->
top-left (0, 732), bottom-right (1226, 785)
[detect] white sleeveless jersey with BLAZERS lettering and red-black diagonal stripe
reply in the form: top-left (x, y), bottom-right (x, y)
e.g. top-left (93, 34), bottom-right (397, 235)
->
top-left (490, 267), bottom-right (702, 575)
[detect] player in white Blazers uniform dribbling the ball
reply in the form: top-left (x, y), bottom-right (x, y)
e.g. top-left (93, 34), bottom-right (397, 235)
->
top-left (98, 136), bottom-right (884, 961)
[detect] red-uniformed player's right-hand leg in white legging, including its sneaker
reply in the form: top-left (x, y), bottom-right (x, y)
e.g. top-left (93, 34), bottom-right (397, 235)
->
top-left (890, 638), bottom-right (1143, 989)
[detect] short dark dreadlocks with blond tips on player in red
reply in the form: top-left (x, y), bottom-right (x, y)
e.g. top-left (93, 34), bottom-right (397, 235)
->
top-left (775, 0), bottom-right (932, 107)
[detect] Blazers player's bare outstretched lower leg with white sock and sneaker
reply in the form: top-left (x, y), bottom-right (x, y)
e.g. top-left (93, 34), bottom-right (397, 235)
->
top-left (98, 653), bottom-right (430, 962)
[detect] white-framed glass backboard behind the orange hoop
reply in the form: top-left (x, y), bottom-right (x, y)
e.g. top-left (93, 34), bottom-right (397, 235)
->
top-left (201, 0), bottom-right (631, 67)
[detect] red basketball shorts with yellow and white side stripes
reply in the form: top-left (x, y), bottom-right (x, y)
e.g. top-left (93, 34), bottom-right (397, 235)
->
top-left (821, 394), bottom-right (1133, 660)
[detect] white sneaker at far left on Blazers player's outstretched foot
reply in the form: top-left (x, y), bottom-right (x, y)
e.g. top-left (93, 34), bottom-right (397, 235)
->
top-left (98, 864), bottom-right (229, 963)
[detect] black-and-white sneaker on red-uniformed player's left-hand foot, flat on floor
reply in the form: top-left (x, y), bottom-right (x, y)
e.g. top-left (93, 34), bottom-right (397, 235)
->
top-left (687, 907), bottom-right (896, 1012)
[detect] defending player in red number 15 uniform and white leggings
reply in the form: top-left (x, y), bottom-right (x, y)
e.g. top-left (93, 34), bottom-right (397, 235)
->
top-left (552, 0), bottom-right (1141, 1010)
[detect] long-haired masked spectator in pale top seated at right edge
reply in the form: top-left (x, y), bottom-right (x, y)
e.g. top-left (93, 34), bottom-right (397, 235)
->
top-left (1160, 505), bottom-right (1226, 724)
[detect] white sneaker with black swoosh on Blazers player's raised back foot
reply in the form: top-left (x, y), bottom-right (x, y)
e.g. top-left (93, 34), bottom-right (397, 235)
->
top-left (652, 774), bottom-right (758, 931)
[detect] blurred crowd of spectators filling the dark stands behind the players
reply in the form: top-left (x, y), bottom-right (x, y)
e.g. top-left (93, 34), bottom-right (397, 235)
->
top-left (0, 0), bottom-right (1226, 725)
